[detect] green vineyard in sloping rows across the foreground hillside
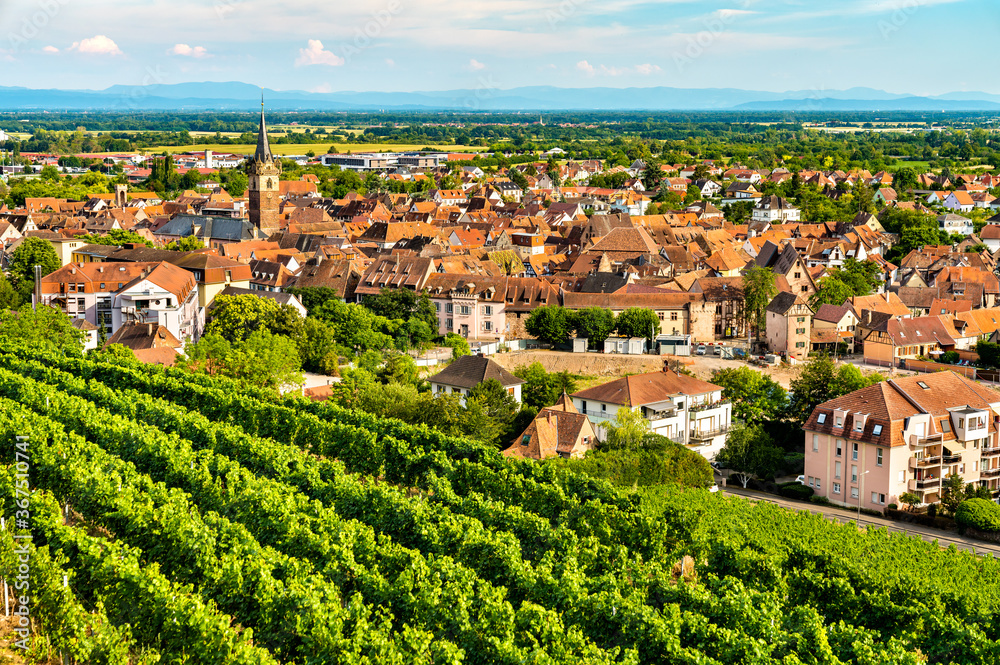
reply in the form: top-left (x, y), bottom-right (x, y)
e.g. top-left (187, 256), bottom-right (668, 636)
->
top-left (0, 340), bottom-right (1000, 665)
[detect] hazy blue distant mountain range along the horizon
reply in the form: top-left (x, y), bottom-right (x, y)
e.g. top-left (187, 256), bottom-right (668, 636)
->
top-left (0, 82), bottom-right (1000, 112)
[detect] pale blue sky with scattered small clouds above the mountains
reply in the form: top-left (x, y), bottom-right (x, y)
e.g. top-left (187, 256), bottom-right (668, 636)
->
top-left (0, 0), bottom-right (1000, 94)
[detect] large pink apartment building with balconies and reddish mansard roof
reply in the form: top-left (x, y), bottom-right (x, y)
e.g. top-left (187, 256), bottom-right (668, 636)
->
top-left (803, 372), bottom-right (1000, 510)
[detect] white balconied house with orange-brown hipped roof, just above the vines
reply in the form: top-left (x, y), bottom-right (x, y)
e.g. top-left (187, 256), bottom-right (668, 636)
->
top-left (570, 367), bottom-right (732, 459)
